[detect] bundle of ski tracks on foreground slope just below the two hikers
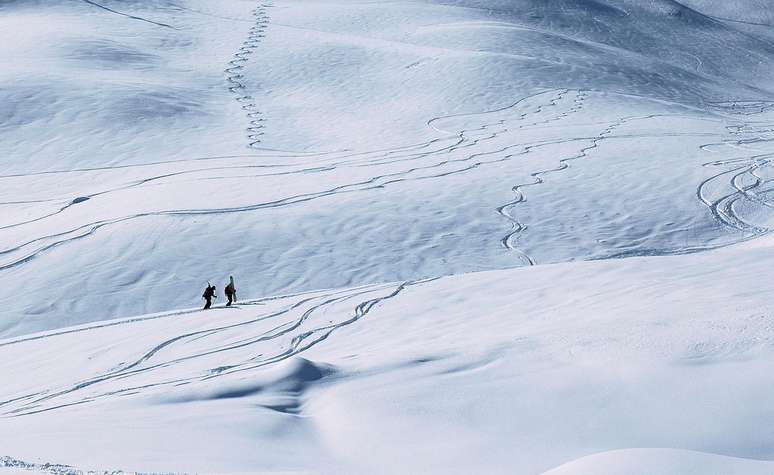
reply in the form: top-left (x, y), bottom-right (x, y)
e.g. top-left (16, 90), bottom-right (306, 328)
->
top-left (0, 279), bottom-right (435, 417)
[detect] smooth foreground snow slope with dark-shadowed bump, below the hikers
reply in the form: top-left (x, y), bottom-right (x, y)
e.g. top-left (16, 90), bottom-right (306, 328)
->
top-left (0, 239), bottom-right (774, 474)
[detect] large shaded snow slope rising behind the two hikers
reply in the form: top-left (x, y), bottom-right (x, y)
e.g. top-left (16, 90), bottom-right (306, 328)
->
top-left (0, 0), bottom-right (774, 336)
